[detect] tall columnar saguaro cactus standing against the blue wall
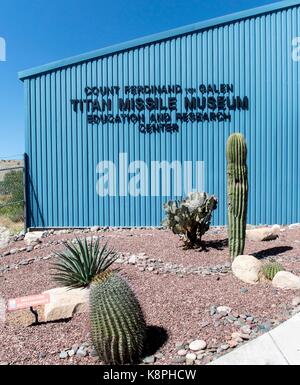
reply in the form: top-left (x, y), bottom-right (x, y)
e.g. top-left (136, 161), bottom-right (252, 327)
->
top-left (226, 133), bottom-right (248, 259)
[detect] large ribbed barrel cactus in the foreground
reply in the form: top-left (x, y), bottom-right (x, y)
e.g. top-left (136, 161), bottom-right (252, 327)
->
top-left (90, 271), bottom-right (146, 365)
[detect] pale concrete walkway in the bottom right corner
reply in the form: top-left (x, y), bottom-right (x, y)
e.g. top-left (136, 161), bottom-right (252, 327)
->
top-left (209, 313), bottom-right (300, 365)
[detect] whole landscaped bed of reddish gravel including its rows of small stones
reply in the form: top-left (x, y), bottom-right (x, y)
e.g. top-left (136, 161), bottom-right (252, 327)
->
top-left (0, 226), bottom-right (300, 365)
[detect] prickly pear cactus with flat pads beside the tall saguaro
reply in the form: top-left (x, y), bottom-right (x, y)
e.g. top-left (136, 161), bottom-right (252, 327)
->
top-left (162, 193), bottom-right (218, 247)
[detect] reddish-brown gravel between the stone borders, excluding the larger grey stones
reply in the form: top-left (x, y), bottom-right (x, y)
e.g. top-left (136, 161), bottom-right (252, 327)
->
top-left (0, 228), bottom-right (300, 365)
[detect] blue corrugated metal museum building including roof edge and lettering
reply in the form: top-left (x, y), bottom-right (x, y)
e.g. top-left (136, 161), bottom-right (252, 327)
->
top-left (19, 1), bottom-right (300, 228)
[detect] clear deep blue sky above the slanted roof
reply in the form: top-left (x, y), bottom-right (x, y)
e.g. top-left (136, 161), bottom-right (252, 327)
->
top-left (0, 0), bottom-right (282, 159)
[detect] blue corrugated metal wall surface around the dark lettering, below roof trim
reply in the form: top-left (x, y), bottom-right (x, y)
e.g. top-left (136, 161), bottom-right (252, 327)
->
top-left (25, 7), bottom-right (300, 228)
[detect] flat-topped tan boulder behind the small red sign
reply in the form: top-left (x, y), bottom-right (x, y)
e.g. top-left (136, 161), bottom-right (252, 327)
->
top-left (44, 287), bottom-right (89, 322)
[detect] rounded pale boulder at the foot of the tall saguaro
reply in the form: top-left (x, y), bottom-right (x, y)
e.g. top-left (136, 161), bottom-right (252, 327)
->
top-left (231, 255), bottom-right (262, 284)
